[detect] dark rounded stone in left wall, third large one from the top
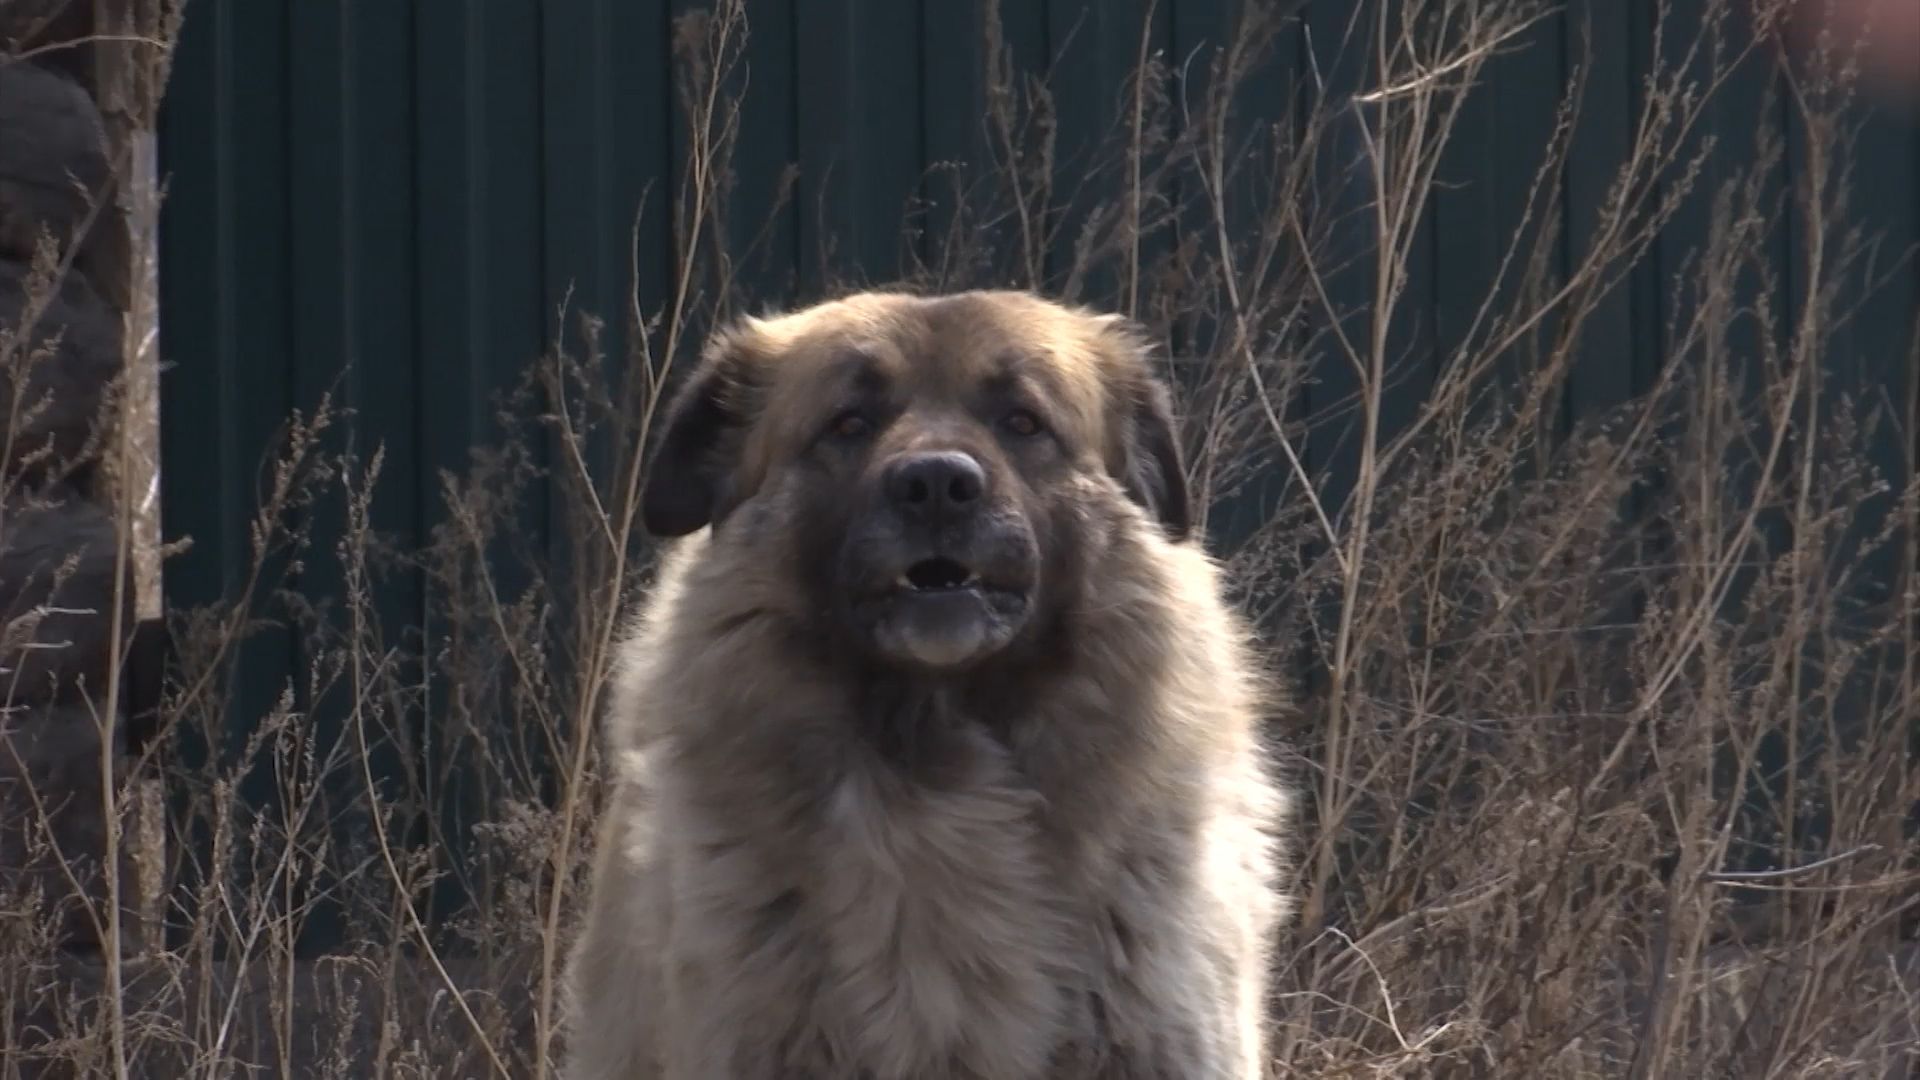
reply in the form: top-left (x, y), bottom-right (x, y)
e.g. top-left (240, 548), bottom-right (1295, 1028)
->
top-left (0, 500), bottom-right (132, 707)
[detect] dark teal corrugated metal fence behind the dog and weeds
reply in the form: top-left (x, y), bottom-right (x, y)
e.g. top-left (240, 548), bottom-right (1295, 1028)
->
top-left (161, 0), bottom-right (1920, 941)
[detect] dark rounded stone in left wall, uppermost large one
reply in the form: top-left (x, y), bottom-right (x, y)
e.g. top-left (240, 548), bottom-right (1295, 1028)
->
top-left (0, 61), bottom-right (125, 290)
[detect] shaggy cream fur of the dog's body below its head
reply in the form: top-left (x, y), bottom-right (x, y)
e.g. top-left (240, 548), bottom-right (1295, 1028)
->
top-left (564, 290), bottom-right (1290, 1080)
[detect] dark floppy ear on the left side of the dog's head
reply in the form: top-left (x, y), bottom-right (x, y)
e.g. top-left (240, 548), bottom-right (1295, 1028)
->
top-left (639, 322), bottom-right (747, 538)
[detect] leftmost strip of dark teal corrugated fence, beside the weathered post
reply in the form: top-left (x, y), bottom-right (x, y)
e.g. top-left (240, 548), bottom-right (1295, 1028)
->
top-left (159, 4), bottom-right (294, 937)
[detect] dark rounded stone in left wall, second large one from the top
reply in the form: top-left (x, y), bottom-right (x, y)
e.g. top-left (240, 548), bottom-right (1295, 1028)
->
top-left (0, 261), bottom-right (121, 484)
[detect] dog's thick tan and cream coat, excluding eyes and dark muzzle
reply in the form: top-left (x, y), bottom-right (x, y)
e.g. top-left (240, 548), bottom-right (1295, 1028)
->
top-left (564, 292), bottom-right (1288, 1080)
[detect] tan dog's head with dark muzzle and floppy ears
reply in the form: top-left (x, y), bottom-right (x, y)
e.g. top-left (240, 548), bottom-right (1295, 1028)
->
top-left (641, 292), bottom-right (1190, 673)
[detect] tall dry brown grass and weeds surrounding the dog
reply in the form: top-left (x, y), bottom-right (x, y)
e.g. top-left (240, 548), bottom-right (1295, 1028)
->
top-left (0, 0), bottom-right (1920, 1080)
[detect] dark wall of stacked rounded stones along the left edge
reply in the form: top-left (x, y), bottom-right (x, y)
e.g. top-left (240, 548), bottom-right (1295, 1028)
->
top-left (0, 0), bottom-right (148, 945)
